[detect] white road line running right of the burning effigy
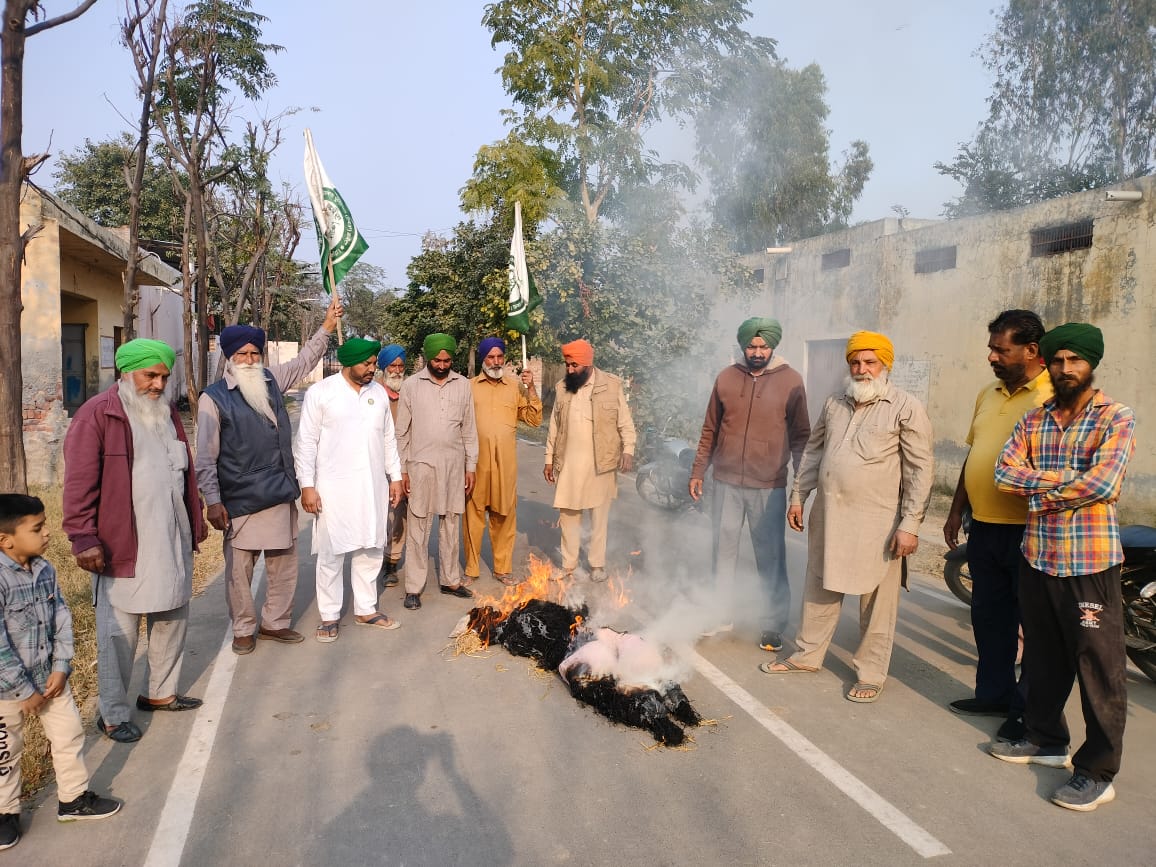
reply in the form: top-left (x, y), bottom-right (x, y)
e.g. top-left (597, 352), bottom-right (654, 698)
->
top-left (691, 652), bottom-right (951, 858)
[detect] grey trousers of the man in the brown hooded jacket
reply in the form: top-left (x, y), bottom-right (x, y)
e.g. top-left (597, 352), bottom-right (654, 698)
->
top-left (711, 482), bottom-right (791, 632)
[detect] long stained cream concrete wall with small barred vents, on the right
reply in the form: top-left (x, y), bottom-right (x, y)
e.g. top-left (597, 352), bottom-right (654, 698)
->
top-left (748, 177), bottom-right (1156, 523)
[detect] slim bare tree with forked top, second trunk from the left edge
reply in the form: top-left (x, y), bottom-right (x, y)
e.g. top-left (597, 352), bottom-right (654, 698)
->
top-left (120, 0), bottom-right (169, 340)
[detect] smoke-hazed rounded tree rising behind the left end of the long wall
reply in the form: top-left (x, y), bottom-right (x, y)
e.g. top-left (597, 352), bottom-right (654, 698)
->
top-left (695, 58), bottom-right (873, 252)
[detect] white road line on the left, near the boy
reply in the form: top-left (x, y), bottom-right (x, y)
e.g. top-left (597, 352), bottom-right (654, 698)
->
top-left (145, 557), bottom-right (265, 867)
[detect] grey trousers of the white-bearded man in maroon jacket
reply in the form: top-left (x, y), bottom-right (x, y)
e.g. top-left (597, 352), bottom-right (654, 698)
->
top-left (95, 577), bottom-right (188, 726)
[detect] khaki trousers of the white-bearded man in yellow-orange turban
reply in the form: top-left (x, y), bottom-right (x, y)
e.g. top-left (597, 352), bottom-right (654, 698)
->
top-left (791, 561), bottom-right (903, 687)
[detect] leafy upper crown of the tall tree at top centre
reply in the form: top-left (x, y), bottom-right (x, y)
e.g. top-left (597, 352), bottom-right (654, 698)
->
top-left (480, 0), bottom-right (773, 223)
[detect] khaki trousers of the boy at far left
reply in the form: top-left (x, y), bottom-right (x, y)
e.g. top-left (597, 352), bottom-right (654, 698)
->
top-left (0, 684), bottom-right (88, 813)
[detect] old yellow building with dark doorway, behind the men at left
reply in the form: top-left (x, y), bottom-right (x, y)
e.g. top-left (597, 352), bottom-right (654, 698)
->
top-left (20, 185), bottom-right (184, 484)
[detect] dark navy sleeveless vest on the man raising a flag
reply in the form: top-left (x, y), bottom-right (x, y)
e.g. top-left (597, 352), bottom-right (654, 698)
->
top-left (205, 371), bottom-right (301, 518)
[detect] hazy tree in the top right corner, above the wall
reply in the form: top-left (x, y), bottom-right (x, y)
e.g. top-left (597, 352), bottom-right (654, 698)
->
top-left (935, 0), bottom-right (1156, 216)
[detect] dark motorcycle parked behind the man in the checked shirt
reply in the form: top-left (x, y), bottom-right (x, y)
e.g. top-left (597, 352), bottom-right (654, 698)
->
top-left (943, 518), bottom-right (1156, 682)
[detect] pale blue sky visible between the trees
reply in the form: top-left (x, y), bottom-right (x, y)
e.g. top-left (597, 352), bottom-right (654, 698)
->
top-left (23, 0), bottom-right (994, 286)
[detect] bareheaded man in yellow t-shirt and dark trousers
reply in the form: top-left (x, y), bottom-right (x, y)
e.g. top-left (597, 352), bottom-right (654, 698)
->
top-left (943, 310), bottom-right (1052, 740)
